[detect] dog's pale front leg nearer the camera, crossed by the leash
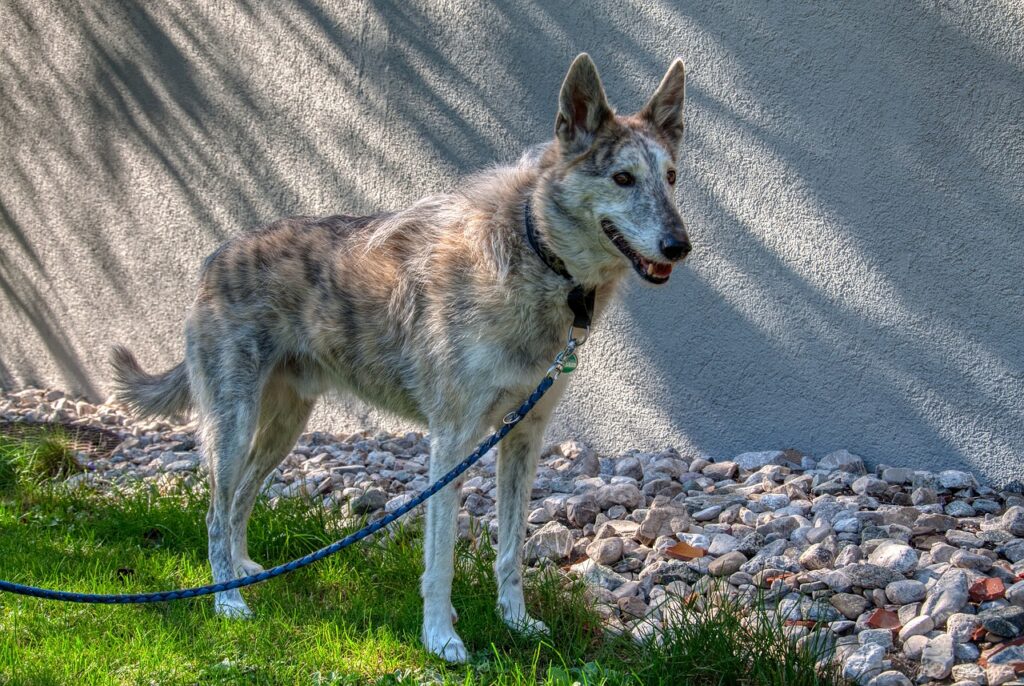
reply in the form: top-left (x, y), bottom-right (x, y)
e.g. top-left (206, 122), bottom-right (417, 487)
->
top-left (421, 425), bottom-right (473, 662)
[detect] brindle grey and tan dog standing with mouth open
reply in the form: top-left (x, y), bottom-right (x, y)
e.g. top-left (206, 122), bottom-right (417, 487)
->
top-left (112, 53), bottom-right (690, 662)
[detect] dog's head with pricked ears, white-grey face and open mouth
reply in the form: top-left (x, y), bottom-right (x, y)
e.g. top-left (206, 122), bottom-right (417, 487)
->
top-left (549, 53), bottom-right (690, 285)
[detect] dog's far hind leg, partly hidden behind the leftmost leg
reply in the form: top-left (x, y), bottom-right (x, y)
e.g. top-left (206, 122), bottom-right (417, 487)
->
top-left (231, 373), bottom-right (316, 576)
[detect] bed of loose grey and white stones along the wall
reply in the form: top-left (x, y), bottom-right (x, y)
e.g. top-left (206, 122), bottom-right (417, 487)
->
top-left (0, 389), bottom-right (1024, 686)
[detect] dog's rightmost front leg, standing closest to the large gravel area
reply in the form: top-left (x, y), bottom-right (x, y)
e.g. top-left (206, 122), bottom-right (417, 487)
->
top-left (495, 408), bottom-right (548, 634)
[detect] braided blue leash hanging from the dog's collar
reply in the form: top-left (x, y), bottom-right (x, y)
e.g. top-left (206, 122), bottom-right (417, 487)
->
top-left (0, 329), bottom-right (585, 605)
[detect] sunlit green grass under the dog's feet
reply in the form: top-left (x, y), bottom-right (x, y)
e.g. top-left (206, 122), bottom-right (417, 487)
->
top-left (0, 436), bottom-right (839, 686)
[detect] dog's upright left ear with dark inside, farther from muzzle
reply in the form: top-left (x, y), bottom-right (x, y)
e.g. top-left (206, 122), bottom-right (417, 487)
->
top-left (555, 52), bottom-right (612, 153)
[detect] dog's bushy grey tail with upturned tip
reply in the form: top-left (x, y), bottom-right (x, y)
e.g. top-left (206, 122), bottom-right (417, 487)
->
top-left (111, 345), bottom-right (193, 418)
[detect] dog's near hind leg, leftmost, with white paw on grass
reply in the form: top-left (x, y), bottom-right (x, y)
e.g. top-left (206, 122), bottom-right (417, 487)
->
top-left (188, 339), bottom-right (265, 617)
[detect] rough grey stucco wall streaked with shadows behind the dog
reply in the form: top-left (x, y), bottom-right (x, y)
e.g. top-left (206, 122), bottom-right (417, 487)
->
top-left (0, 0), bottom-right (1024, 483)
